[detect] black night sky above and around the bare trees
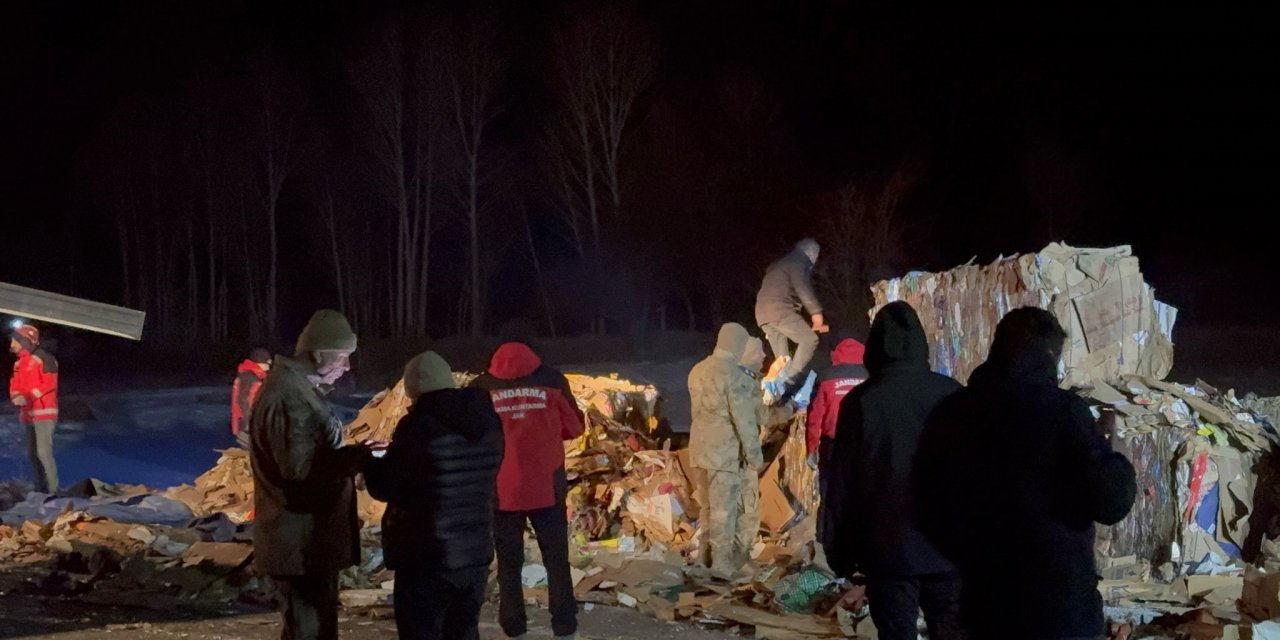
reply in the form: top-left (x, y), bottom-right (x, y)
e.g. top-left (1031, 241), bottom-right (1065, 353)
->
top-left (0, 1), bottom-right (1280, 334)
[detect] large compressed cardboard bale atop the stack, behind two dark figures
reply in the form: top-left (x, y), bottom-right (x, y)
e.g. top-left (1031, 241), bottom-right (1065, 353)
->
top-left (872, 243), bottom-right (1178, 387)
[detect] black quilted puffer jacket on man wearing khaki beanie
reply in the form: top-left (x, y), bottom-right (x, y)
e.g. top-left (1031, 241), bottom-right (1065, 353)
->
top-left (365, 389), bottom-right (503, 570)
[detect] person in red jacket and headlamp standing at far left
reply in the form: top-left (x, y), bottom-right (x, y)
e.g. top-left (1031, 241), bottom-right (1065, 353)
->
top-left (9, 324), bottom-right (58, 494)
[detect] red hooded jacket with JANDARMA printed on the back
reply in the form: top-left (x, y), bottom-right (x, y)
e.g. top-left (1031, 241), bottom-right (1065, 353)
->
top-left (472, 342), bottom-right (584, 511)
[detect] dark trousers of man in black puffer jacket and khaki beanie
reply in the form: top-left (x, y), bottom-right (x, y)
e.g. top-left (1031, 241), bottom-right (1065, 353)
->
top-left (396, 567), bottom-right (489, 640)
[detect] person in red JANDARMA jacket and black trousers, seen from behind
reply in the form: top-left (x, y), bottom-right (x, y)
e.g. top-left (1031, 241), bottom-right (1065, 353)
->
top-left (472, 342), bottom-right (584, 639)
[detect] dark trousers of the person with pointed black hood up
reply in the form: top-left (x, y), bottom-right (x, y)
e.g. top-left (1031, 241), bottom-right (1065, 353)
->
top-left (867, 573), bottom-right (965, 640)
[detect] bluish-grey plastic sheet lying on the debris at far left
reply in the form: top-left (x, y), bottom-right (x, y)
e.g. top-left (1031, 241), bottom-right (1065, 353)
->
top-left (0, 493), bottom-right (196, 527)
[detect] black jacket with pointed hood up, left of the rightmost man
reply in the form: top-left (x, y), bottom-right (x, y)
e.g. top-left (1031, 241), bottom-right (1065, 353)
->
top-left (824, 302), bottom-right (960, 577)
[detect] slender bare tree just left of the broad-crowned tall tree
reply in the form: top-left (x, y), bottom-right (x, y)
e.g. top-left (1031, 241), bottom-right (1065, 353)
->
top-left (445, 19), bottom-right (507, 335)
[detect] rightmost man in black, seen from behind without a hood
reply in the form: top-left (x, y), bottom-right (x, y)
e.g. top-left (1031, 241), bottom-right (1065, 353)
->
top-left (916, 307), bottom-right (1135, 640)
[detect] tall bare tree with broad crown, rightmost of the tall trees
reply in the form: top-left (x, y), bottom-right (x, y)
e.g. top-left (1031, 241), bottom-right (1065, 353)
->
top-left (544, 0), bottom-right (658, 260)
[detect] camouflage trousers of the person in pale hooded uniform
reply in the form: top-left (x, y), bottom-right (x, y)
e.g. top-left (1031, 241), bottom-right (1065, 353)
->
top-left (707, 468), bottom-right (760, 573)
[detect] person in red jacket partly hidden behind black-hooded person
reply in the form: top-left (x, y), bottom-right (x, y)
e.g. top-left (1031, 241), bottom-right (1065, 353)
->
top-left (805, 338), bottom-right (870, 540)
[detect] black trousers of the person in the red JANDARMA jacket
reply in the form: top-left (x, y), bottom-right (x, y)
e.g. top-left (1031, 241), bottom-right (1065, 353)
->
top-left (493, 471), bottom-right (577, 637)
